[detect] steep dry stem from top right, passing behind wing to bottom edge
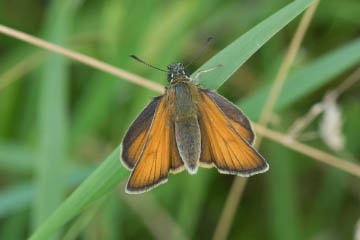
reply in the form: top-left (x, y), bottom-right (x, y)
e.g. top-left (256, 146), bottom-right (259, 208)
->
top-left (213, 0), bottom-right (319, 240)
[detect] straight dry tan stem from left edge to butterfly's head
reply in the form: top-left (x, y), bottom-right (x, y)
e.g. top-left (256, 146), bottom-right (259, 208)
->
top-left (0, 25), bottom-right (164, 93)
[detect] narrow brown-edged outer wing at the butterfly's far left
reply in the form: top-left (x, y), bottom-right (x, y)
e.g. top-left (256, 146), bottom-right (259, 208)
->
top-left (121, 96), bottom-right (162, 169)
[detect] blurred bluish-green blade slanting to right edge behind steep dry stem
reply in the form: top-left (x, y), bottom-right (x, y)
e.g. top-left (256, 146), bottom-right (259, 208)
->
top-left (237, 39), bottom-right (360, 121)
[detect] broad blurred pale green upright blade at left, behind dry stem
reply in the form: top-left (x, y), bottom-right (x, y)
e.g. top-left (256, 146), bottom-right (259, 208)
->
top-left (33, 0), bottom-right (80, 232)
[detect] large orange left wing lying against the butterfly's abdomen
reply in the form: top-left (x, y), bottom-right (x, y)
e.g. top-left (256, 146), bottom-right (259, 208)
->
top-left (126, 97), bottom-right (183, 193)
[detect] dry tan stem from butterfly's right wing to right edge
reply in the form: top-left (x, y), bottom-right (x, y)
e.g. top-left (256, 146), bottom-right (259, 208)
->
top-left (253, 124), bottom-right (360, 177)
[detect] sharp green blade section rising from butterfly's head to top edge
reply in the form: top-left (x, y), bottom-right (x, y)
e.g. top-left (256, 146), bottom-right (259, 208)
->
top-left (199, 0), bottom-right (314, 89)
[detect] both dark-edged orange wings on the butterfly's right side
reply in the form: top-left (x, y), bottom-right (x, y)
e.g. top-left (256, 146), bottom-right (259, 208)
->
top-left (198, 89), bottom-right (268, 176)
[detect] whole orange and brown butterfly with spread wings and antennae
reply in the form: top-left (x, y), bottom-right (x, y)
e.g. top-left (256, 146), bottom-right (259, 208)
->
top-left (121, 56), bottom-right (269, 193)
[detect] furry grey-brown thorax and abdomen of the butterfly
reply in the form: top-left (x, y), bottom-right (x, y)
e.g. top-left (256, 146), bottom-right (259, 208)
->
top-left (173, 82), bottom-right (201, 173)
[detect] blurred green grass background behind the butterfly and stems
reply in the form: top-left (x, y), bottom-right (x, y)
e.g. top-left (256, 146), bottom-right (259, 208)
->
top-left (0, 0), bottom-right (360, 240)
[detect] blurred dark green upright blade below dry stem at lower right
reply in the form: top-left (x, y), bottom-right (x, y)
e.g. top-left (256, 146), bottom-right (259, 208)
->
top-left (266, 142), bottom-right (304, 240)
